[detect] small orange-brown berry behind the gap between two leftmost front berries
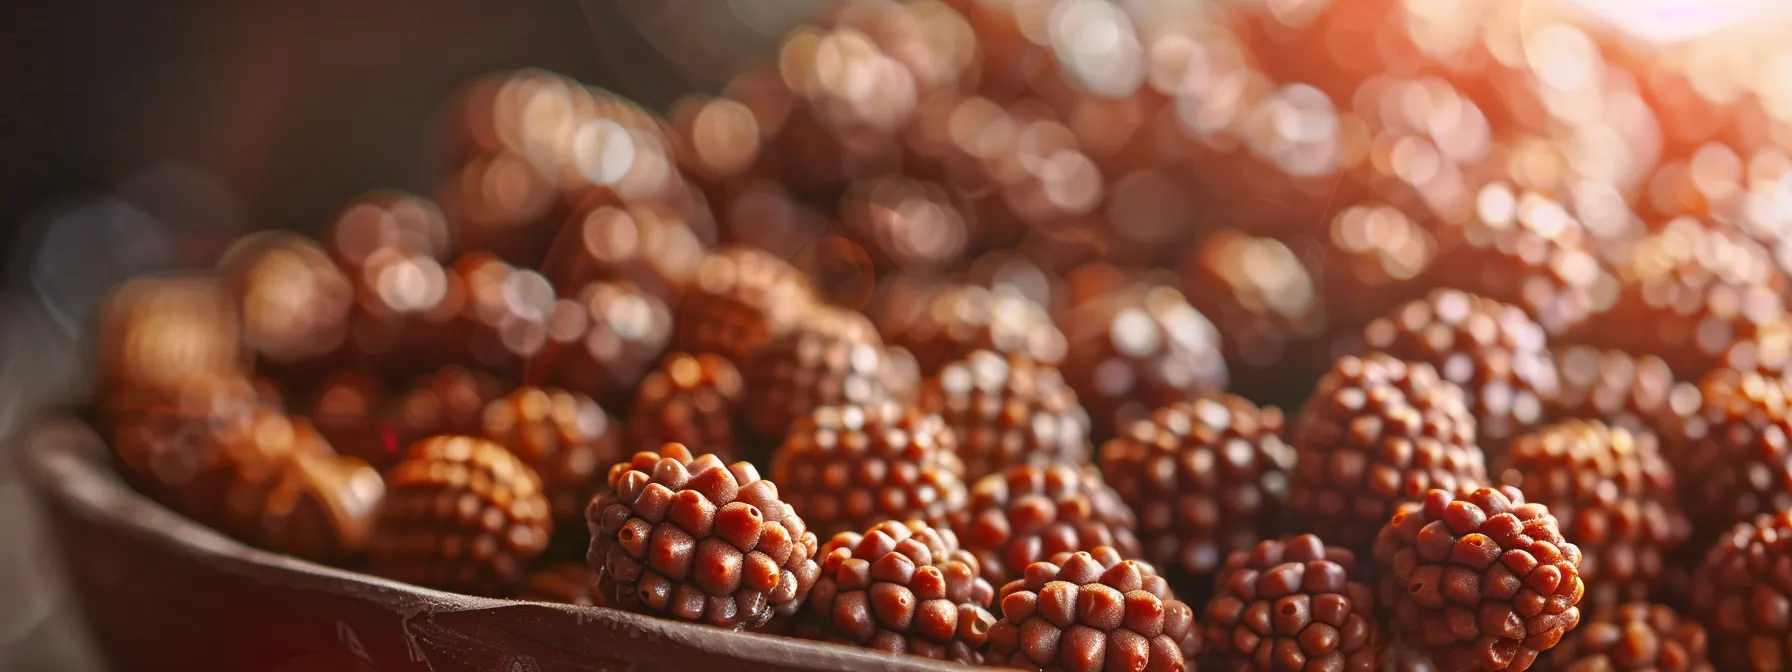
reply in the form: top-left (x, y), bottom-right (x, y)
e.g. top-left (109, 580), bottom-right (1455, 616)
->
top-left (484, 387), bottom-right (627, 529)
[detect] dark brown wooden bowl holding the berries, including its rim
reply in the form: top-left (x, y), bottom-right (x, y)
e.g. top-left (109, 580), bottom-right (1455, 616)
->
top-left (16, 414), bottom-right (946, 672)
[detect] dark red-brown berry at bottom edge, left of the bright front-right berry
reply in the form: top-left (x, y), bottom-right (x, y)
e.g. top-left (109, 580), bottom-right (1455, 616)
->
top-left (1204, 534), bottom-right (1389, 672)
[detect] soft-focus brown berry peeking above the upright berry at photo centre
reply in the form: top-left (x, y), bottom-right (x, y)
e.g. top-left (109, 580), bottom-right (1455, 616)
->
top-left (874, 283), bottom-right (1068, 375)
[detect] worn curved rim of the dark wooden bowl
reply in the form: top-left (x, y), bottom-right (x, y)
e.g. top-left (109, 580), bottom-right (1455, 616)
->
top-left (11, 412), bottom-right (962, 672)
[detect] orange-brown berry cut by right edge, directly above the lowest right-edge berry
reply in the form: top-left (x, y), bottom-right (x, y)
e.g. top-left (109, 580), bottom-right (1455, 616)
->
top-left (1668, 369), bottom-right (1792, 530)
